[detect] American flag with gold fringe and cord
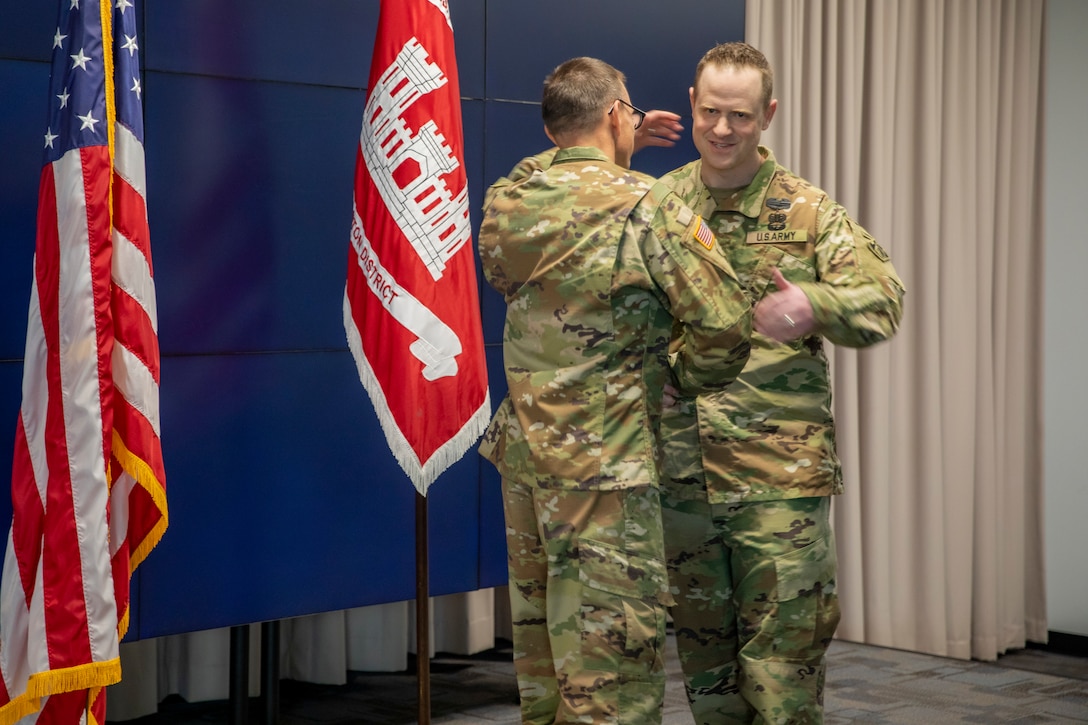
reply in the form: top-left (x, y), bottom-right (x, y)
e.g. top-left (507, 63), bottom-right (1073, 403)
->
top-left (0, 0), bottom-right (166, 725)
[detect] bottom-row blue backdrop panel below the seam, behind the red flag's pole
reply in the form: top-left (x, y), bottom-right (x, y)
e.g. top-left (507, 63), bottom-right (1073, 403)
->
top-left (130, 351), bottom-right (494, 637)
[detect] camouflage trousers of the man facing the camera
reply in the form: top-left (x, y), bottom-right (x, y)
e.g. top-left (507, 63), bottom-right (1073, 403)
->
top-left (662, 487), bottom-right (839, 725)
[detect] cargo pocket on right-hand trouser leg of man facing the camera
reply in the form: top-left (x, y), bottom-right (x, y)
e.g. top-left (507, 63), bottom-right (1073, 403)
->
top-left (772, 533), bottom-right (840, 662)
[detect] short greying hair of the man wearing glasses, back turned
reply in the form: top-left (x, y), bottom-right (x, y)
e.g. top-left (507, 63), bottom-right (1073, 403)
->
top-left (541, 57), bottom-right (627, 136)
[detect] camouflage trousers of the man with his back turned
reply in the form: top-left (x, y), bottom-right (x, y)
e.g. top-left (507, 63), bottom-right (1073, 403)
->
top-left (503, 480), bottom-right (672, 725)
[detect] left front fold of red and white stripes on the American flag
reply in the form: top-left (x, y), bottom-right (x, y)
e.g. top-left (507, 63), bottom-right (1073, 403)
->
top-left (0, 142), bottom-right (120, 721)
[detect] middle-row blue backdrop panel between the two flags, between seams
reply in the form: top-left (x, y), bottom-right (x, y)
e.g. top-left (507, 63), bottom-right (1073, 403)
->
top-left (145, 72), bottom-right (363, 354)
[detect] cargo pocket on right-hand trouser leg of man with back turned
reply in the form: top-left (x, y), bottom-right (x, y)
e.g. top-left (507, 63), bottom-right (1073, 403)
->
top-left (578, 539), bottom-right (666, 680)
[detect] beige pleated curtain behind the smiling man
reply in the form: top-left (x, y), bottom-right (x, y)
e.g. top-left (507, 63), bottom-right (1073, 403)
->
top-left (745, 0), bottom-right (1047, 660)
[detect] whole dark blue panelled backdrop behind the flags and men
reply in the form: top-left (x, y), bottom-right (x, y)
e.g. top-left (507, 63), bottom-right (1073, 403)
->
top-left (0, 0), bottom-right (743, 639)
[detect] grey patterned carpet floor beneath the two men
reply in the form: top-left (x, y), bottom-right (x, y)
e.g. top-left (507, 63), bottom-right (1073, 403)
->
top-left (119, 638), bottom-right (1088, 725)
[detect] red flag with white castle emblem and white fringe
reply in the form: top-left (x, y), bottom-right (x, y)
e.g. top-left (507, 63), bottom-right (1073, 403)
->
top-left (344, 0), bottom-right (491, 495)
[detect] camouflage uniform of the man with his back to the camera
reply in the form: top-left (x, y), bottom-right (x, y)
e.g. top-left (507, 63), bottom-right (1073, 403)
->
top-left (479, 147), bottom-right (751, 724)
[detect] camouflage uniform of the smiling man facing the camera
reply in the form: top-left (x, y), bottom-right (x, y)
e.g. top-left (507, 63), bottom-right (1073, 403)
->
top-left (662, 147), bottom-right (903, 724)
